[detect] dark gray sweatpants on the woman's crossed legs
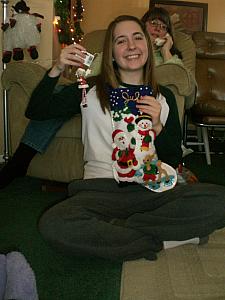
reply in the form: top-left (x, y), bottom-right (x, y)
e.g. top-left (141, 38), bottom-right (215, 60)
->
top-left (39, 179), bottom-right (225, 260)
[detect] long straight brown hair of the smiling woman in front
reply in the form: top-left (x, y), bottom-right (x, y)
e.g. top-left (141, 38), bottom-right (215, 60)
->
top-left (96, 15), bottom-right (158, 113)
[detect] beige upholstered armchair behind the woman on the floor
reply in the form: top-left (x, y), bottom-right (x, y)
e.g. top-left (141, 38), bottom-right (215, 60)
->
top-left (2, 30), bottom-right (195, 182)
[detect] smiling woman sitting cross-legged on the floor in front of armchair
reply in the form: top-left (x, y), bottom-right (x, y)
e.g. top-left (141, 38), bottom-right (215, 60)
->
top-left (23, 16), bottom-right (225, 260)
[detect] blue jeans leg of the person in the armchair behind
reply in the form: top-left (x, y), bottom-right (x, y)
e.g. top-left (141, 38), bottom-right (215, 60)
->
top-left (21, 118), bottom-right (69, 153)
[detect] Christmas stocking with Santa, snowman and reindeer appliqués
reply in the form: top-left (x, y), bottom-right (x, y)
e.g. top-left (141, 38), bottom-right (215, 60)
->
top-left (110, 86), bottom-right (177, 192)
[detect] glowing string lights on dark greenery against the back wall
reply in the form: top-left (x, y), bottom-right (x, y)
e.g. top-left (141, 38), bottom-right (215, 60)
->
top-left (54, 0), bottom-right (84, 45)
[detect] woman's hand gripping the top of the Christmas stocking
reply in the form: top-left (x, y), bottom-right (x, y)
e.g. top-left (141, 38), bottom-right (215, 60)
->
top-left (136, 96), bottom-right (163, 135)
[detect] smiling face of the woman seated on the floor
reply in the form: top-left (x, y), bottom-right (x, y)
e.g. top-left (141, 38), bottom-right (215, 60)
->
top-left (113, 21), bottom-right (148, 78)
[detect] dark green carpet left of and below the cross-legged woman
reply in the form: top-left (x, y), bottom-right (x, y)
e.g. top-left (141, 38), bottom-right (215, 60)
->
top-left (0, 177), bottom-right (122, 300)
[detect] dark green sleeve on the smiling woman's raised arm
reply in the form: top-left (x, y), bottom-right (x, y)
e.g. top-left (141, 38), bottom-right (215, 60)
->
top-left (25, 72), bottom-right (82, 120)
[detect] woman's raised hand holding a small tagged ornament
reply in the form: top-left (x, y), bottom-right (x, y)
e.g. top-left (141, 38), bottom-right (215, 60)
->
top-left (48, 44), bottom-right (86, 77)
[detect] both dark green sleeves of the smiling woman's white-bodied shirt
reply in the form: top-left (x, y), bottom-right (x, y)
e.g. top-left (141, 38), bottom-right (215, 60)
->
top-left (25, 73), bottom-right (182, 168)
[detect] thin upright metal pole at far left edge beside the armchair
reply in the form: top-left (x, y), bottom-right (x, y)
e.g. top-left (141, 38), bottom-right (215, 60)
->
top-left (1, 0), bottom-right (9, 161)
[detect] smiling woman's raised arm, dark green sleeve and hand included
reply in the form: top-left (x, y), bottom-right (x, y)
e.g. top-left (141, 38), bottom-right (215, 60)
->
top-left (25, 44), bottom-right (86, 120)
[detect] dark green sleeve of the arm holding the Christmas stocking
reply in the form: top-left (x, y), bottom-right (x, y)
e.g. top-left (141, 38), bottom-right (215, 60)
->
top-left (155, 86), bottom-right (182, 168)
